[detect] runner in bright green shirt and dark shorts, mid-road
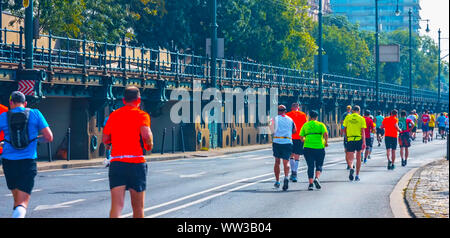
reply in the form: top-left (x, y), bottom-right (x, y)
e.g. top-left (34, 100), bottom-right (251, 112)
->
top-left (300, 111), bottom-right (328, 190)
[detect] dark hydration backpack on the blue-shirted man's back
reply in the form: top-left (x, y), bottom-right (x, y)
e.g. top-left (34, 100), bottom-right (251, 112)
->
top-left (5, 108), bottom-right (37, 150)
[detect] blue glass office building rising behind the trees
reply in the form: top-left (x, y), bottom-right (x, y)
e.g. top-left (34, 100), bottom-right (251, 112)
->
top-left (330, 0), bottom-right (420, 33)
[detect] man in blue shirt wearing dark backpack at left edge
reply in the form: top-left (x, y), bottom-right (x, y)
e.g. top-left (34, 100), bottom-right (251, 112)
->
top-left (0, 91), bottom-right (53, 218)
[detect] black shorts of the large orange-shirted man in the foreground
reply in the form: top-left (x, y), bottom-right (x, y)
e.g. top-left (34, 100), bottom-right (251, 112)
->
top-left (109, 161), bottom-right (148, 192)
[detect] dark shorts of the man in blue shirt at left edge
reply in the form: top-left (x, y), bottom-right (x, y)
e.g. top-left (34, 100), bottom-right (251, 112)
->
top-left (2, 159), bottom-right (37, 194)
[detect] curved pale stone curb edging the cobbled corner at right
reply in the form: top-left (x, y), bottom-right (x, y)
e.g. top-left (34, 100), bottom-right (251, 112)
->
top-left (404, 159), bottom-right (442, 218)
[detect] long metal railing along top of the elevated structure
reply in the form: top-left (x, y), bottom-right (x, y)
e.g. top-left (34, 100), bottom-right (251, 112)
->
top-left (0, 27), bottom-right (448, 103)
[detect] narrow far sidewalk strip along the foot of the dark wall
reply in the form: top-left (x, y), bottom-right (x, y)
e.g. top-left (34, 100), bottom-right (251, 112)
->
top-left (0, 137), bottom-right (342, 175)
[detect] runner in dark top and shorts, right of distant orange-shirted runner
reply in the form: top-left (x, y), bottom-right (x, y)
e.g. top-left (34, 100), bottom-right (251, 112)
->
top-left (398, 111), bottom-right (414, 167)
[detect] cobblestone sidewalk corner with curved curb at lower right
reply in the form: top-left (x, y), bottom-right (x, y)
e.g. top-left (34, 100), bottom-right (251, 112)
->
top-left (405, 159), bottom-right (449, 218)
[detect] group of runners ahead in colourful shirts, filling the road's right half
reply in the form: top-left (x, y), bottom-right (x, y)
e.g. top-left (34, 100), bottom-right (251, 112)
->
top-left (271, 103), bottom-right (449, 190)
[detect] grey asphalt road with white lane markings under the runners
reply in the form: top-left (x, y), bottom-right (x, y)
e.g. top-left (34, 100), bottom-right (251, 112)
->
top-left (0, 132), bottom-right (446, 218)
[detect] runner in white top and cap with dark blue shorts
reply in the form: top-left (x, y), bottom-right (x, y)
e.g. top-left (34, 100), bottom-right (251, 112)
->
top-left (270, 105), bottom-right (297, 191)
